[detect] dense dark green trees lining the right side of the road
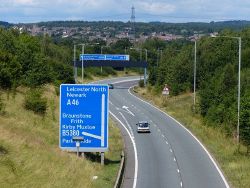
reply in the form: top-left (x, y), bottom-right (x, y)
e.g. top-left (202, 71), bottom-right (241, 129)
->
top-left (142, 29), bottom-right (250, 148)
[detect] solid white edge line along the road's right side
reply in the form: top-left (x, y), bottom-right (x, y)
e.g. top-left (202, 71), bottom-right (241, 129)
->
top-left (128, 86), bottom-right (230, 188)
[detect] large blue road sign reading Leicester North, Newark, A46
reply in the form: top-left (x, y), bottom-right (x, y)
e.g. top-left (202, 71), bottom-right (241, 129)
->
top-left (59, 84), bottom-right (109, 152)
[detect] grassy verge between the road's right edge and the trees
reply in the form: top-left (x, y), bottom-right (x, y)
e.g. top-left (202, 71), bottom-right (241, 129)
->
top-left (136, 88), bottom-right (250, 188)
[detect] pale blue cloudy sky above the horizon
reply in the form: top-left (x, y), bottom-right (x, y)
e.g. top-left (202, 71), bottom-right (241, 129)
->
top-left (0, 0), bottom-right (250, 23)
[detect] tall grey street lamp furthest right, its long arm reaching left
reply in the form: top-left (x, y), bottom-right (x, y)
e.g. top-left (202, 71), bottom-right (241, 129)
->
top-left (212, 36), bottom-right (241, 144)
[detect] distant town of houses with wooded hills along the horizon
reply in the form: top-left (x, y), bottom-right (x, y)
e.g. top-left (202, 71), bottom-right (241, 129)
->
top-left (0, 21), bottom-right (250, 45)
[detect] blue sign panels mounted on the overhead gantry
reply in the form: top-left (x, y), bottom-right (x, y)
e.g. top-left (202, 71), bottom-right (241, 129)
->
top-left (80, 54), bottom-right (129, 61)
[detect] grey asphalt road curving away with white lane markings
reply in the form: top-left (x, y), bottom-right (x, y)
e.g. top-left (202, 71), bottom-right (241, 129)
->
top-left (94, 77), bottom-right (229, 188)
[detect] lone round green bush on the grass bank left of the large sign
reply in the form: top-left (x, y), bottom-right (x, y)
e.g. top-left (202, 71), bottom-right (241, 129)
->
top-left (24, 89), bottom-right (47, 115)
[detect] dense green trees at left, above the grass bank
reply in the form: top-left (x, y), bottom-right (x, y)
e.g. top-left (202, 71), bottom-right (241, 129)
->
top-left (0, 28), bottom-right (74, 89)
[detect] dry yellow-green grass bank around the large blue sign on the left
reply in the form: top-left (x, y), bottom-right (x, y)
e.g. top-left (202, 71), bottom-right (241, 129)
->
top-left (0, 86), bottom-right (123, 188)
